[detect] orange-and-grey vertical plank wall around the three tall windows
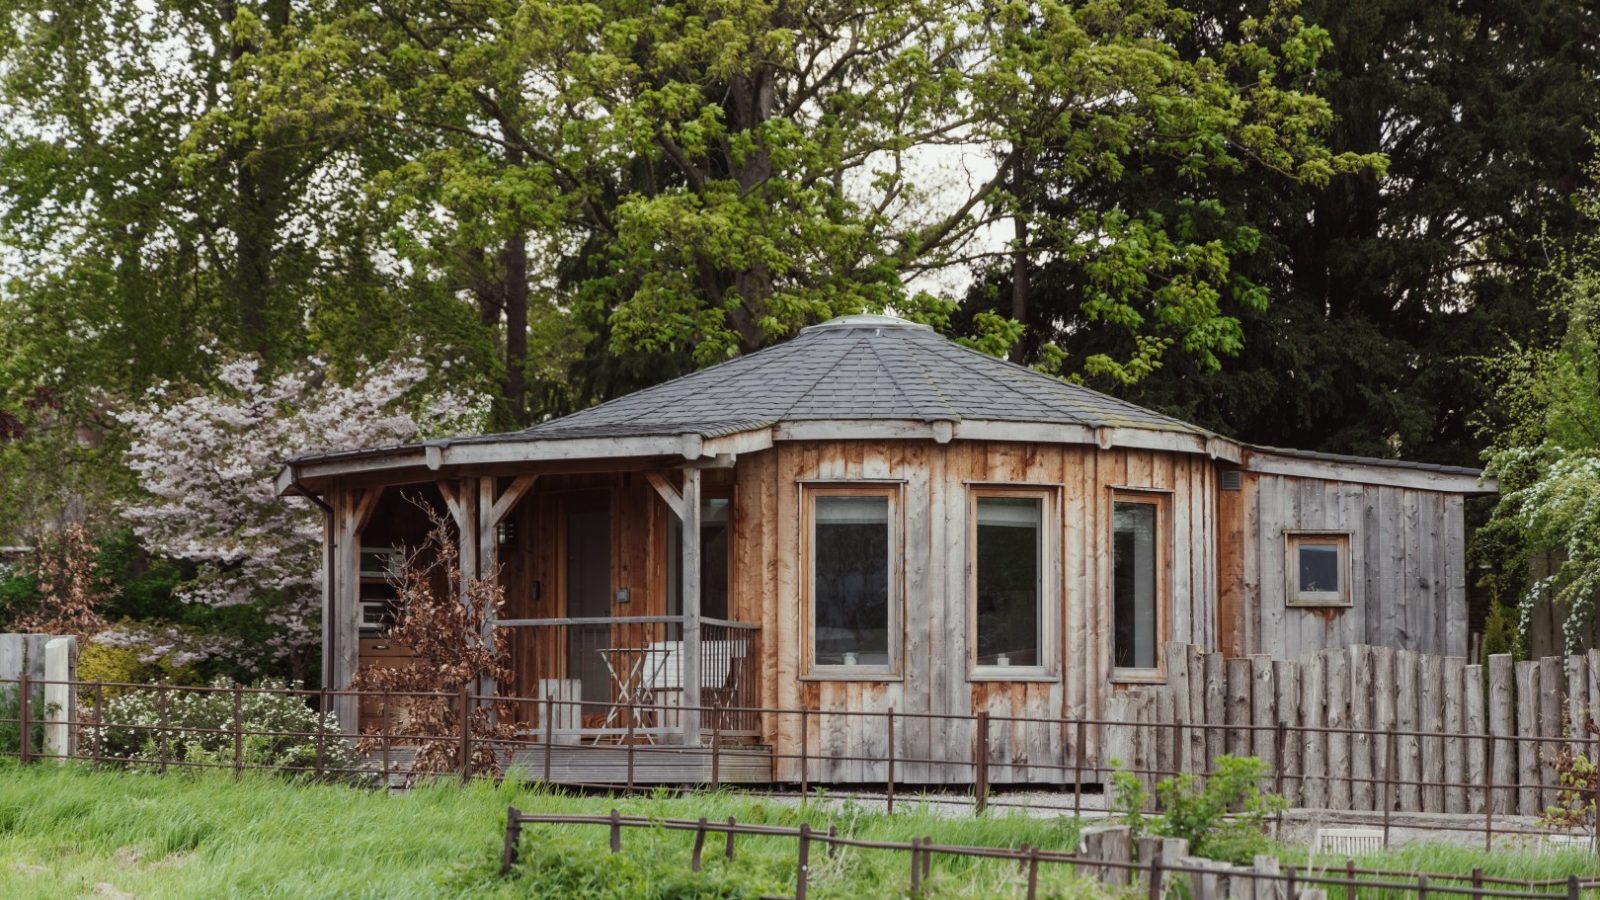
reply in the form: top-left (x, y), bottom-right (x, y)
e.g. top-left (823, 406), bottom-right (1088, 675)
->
top-left (733, 440), bottom-right (1218, 781)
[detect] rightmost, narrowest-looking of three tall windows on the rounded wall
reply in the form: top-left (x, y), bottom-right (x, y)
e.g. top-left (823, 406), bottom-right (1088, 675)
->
top-left (1110, 495), bottom-right (1166, 676)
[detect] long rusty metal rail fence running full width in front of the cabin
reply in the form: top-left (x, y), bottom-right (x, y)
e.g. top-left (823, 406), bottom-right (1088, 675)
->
top-left (0, 674), bottom-right (1600, 849)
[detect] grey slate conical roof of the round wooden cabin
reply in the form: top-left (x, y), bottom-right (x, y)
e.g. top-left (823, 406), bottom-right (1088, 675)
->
top-left (486, 315), bottom-right (1210, 442)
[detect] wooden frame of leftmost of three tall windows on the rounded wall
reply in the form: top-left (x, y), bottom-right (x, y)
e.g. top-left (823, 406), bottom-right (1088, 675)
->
top-left (798, 480), bottom-right (906, 681)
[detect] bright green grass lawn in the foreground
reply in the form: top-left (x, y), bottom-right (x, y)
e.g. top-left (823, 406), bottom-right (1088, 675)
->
top-left (0, 762), bottom-right (1597, 898)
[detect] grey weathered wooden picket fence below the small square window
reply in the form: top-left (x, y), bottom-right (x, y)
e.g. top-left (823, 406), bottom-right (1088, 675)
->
top-left (1106, 644), bottom-right (1600, 815)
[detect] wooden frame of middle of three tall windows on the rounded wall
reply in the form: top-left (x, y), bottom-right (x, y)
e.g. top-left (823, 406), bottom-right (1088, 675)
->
top-left (966, 484), bottom-right (1061, 682)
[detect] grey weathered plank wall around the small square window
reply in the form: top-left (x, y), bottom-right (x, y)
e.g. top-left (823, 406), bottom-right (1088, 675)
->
top-left (1219, 472), bottom-right (1467, 660)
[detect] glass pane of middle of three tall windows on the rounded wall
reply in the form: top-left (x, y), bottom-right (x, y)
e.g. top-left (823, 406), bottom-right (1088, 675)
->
top-left (974, 496), bottom-right (1043, 666)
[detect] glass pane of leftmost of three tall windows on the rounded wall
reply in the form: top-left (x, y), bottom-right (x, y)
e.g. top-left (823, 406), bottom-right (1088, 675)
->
top-left (811, 496), bottom-right (890, 666)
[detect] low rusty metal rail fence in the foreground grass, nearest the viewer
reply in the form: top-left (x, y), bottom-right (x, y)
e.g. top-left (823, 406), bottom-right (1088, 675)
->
top-left (501, 807), bottom-right (1600, 900)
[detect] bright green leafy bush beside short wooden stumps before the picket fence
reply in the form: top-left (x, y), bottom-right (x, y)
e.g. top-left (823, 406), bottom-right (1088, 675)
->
top-left (1112, 754), bottom-right (1288, 863)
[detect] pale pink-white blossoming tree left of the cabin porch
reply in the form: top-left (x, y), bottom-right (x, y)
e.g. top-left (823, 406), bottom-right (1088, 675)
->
top-left (118, 359), bottom-right (485, 660)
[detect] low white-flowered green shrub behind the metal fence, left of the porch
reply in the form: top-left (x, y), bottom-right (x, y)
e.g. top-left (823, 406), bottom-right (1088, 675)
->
top-left (82, 679), bottom-right (360, 772)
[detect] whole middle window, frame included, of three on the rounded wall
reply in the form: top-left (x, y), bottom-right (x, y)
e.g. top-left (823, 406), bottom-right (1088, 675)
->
top-left (971, 490), bottom-right (1048, 677)
